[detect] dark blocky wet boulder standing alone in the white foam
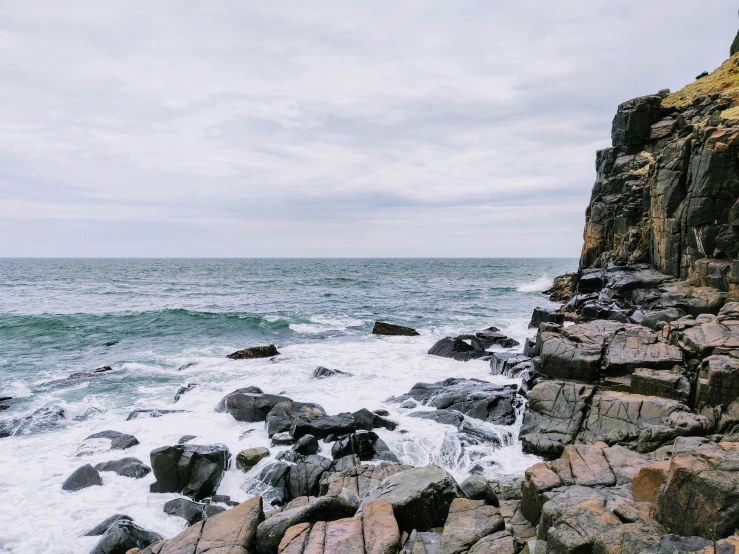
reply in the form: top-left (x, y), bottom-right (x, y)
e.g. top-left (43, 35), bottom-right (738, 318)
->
top-left (151, 444), bottom-right (231, 500)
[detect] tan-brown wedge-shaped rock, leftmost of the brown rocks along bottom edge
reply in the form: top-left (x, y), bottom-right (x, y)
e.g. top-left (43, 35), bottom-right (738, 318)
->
top-left (139, 496), bottom-right (264, 554)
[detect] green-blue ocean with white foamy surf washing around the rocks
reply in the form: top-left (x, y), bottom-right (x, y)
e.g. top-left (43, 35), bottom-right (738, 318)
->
top-left (0, 259), bottom-right (577, 554)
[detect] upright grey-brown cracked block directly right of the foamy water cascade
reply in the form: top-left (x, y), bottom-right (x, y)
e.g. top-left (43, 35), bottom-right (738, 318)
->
top-left (519, 381), bottom-right (595, 457)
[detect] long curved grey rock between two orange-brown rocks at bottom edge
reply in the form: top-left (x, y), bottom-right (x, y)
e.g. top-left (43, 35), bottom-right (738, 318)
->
top-left (256, 493), bottom-right (359, 554)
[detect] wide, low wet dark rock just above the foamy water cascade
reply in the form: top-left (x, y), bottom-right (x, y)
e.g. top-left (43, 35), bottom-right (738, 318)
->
top-left (393, 378), bottom-right (518, 425)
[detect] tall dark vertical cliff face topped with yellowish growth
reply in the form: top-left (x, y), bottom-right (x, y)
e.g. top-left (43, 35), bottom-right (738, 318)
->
top-left (580, 55), bottom-right (739, 290)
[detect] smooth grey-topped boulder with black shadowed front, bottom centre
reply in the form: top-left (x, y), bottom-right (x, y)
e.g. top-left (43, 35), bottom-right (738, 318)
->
top-left (362, 466), bottom-right (464, 532)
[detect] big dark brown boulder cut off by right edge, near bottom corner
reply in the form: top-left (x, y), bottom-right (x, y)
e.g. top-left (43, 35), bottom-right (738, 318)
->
top-left (655, 442), bottom-right (739, 540)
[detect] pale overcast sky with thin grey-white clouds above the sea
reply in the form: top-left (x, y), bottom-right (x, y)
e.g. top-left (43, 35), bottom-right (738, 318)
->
top-left (0, 0), bottom-right (739, 257)
